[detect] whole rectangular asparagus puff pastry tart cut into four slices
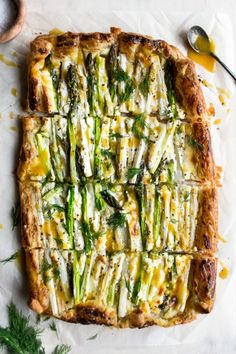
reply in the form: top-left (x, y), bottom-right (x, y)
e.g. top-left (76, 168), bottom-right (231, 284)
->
top-left (17, 28), bottom-right (218, 328)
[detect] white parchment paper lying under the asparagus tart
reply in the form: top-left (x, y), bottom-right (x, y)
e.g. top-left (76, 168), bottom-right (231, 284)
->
top-left (0, 9), bottom-right (236, 354)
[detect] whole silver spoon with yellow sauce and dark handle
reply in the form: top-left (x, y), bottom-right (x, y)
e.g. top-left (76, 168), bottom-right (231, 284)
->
top-left (187, 26), bottom-right (236, 81)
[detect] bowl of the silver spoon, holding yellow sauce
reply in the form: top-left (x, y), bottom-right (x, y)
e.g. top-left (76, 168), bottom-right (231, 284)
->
top-left (187, 26), bottom-right (211, 55)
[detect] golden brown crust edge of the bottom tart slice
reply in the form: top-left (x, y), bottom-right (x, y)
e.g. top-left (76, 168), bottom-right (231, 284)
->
top-left (26, 250), bottom-right (217, 328)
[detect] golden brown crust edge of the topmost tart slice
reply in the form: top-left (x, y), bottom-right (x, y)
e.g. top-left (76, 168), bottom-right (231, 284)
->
top-left (28, 28), bottom-right (206, 120)
